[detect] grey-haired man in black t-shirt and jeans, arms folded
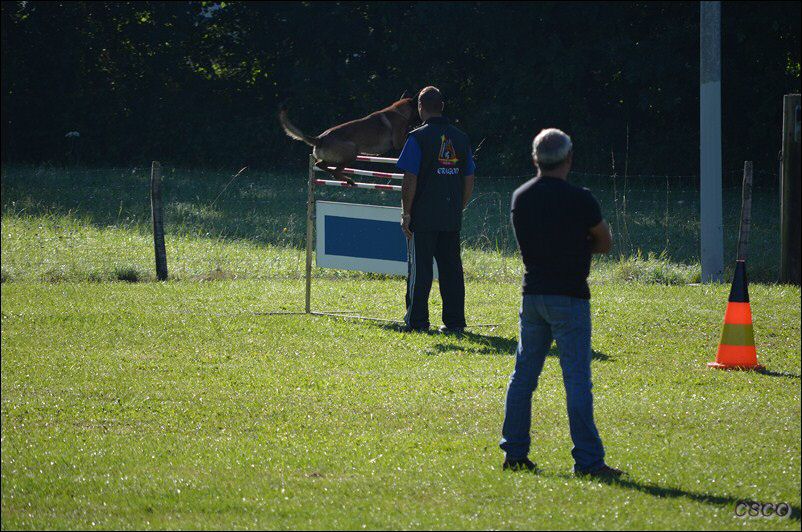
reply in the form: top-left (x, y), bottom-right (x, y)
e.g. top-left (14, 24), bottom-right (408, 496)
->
top-left (501, 129), bottom-right (622, 477)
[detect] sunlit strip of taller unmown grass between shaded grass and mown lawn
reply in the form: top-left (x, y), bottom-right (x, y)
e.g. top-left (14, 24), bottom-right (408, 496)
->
top-left (2, 208), bottom-right (699, 284)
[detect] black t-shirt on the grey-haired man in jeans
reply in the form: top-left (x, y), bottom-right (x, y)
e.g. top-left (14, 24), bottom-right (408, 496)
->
top-left (511, 176), bottom-right (602, 299)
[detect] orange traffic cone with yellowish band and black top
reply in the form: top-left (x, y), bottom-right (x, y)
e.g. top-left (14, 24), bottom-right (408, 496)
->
top-left (707, 260), bottom-right (763, 370)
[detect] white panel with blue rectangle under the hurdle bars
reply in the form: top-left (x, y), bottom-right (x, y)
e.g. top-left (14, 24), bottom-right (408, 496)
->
top-left (315, 201), bottom-right (407, 275)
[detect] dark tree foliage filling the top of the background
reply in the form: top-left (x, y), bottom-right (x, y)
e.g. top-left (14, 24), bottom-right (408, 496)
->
top-left (2, 2), bottom-right (800, 181)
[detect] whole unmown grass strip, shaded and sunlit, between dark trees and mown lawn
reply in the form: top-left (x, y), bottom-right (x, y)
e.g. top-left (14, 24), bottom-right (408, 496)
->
top-left (2, 166), bottom-right (779, 284)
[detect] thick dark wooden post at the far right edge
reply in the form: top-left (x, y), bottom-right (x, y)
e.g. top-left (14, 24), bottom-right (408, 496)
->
top-left (780, 94), bottom-right (802, 284)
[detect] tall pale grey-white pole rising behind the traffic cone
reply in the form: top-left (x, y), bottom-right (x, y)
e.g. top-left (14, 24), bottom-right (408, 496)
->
top-left (699, 2), bottom-right (724, 283)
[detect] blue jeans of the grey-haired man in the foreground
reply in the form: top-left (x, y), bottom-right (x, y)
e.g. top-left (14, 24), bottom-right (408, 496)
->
top-left (501, 295), bottom-right (604, 472)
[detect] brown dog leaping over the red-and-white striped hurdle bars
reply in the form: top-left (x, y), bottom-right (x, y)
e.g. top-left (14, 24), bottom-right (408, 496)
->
top-left (278, 92), bottom-right (418, 185)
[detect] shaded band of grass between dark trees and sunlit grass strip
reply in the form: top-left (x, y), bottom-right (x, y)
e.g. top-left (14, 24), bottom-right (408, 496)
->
top-left (2, 166), bottom-right (779, 279)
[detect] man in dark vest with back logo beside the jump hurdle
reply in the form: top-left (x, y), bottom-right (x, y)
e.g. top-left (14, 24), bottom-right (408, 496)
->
top-left (397, 86), bottom-right (476, 333)
